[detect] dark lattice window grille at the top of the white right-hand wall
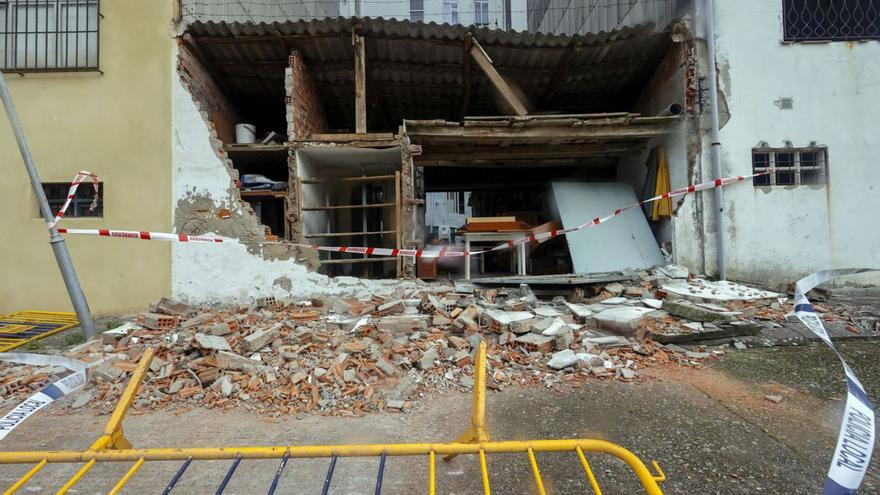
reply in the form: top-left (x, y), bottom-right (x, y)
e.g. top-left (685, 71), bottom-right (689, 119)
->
top-left (782, 0), bottom-right (880, 42)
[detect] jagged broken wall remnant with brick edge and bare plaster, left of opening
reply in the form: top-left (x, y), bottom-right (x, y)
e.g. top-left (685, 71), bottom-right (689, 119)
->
top-left (171, 42), bottom-right (394, 303)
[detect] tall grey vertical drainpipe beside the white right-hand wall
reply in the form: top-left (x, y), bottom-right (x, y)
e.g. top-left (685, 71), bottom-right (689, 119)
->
top-left (705, 0), bottom-right (727, 280)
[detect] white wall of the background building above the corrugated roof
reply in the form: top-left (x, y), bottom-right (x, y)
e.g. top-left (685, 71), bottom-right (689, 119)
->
top-left (339, 0), bottom-right (527, 31)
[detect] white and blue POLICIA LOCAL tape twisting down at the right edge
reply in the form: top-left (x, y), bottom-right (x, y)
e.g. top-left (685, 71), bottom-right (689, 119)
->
top-left (794, 268), bottom-right (880, 495)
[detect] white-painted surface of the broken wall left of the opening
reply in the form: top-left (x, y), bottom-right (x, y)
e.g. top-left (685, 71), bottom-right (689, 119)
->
top-left (170, 45), bottom-right (414, 304)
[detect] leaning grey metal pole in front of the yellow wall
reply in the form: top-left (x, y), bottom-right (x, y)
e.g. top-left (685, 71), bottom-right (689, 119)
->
top-left (0, 73), bottom-right (98, 340)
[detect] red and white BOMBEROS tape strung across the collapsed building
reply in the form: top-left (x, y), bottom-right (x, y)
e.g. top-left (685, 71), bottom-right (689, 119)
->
top-left (50, 172), bottom-right (768, 258)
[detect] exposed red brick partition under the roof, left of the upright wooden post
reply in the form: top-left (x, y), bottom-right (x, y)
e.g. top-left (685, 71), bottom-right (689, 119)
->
top-left (284, 50), bottom-right (327, 141)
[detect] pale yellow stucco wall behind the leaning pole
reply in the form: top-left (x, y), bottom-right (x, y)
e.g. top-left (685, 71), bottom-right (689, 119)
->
top-left (0, 0), bottom-right (174, 314)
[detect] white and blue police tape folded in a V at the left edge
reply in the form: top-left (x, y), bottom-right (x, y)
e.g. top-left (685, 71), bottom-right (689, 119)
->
top-left (0, 352), bottom-right (89, 441)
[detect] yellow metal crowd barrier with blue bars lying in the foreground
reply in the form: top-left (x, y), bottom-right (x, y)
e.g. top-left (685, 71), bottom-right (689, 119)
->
top-left (0, 343), bottom-right (666, 495)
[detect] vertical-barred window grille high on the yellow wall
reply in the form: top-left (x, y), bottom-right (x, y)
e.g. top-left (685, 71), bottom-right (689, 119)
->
top-left (0, 0), bottom-right (100, 72)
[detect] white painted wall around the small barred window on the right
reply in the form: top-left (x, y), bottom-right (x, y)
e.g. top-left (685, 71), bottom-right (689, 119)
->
top-left (688, 0), bottom-right (880, 284)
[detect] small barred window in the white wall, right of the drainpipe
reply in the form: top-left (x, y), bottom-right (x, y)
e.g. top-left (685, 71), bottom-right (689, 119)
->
top-left (752, 148), bottom-right (828, 186)
